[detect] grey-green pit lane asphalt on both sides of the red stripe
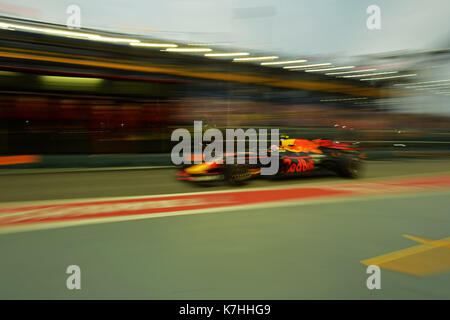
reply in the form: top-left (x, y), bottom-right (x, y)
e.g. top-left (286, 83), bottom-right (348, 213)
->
top-left (0, 161), bottom-right (450, 299)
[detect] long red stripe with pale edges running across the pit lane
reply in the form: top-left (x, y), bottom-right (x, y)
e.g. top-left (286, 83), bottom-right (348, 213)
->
top-left (0, 175), bottom-right (450, 227)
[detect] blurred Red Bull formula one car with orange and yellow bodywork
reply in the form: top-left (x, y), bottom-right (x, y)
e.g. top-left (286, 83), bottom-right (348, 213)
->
top-left (176, 139), bottom-right (365, 185)
